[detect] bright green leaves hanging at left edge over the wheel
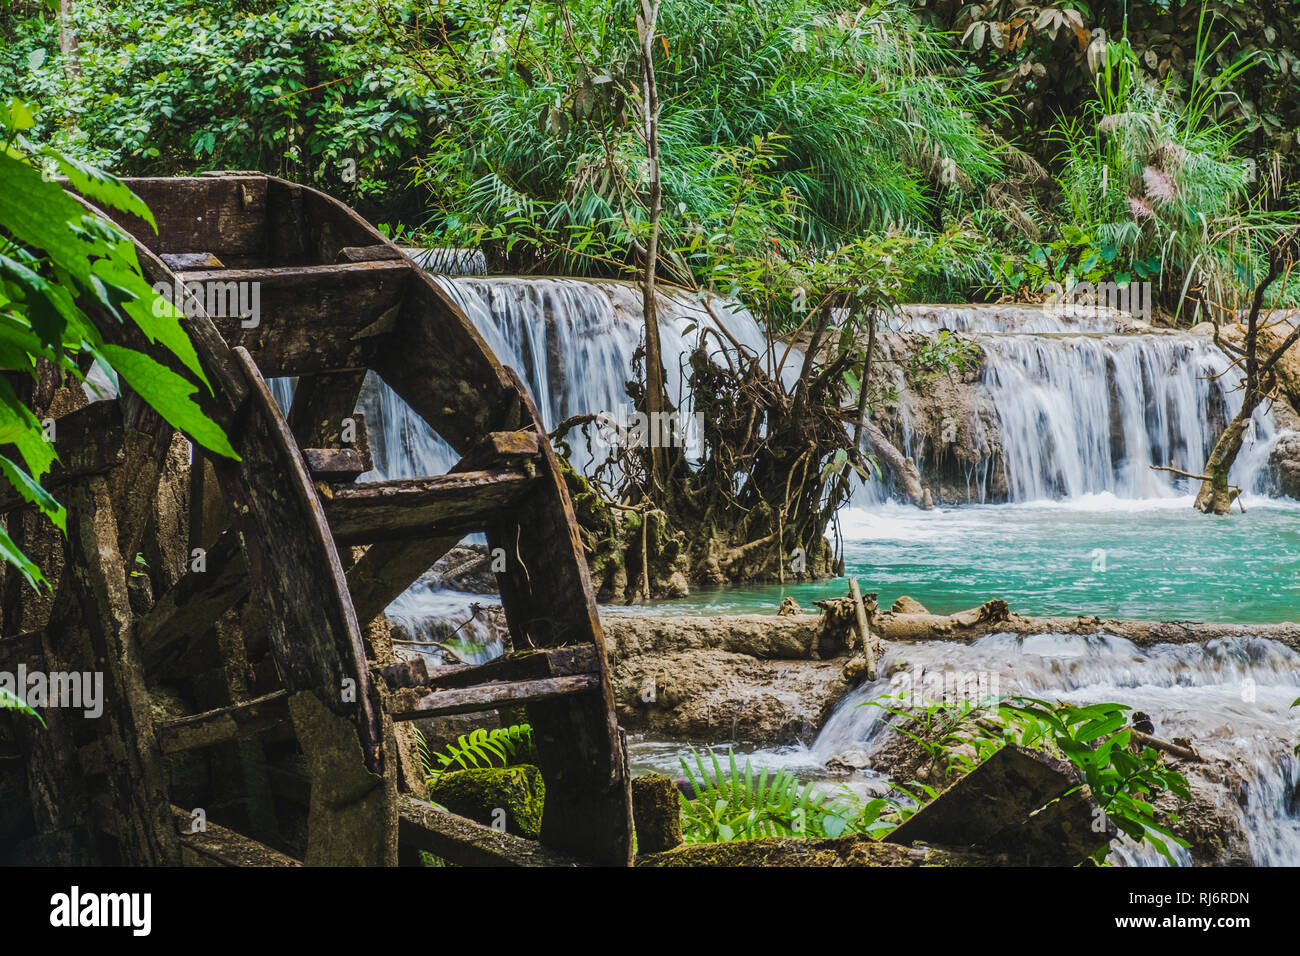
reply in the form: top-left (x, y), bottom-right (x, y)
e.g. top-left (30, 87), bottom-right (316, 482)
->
top-left (0, 99), bottom-right (235, 588)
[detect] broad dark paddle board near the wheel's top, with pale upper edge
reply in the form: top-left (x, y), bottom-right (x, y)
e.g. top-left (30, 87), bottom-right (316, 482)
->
top-left (177, 261), bottom-right (415, 377)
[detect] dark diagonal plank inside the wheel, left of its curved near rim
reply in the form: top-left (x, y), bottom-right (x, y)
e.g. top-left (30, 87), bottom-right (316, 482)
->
top-left (135, 531), bottom-right (250, 672)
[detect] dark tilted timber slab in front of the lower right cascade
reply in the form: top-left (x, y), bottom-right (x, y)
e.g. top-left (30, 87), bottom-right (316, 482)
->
top-left (884, 744), bottom-right (1079, 847)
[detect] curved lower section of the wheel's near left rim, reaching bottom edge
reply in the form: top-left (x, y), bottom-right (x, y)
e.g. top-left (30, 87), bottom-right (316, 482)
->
top-left (217, 349), bottom-right (397, 865)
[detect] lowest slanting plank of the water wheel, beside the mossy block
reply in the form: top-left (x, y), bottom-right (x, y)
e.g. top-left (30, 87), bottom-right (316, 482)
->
top-left (398, 796), bottom-right (582, 866)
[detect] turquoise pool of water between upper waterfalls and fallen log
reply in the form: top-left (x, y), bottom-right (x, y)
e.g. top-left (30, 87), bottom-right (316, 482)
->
top-left (610, 494), bottom-right (1300, 623)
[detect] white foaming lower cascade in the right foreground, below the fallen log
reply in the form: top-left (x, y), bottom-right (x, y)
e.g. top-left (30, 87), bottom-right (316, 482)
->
top-left (806, 635), bottom-right (1300, 866)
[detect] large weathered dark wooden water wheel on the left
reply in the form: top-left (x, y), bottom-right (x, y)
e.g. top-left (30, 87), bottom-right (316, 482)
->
top-left (0, 173), bottom-right (632, 865)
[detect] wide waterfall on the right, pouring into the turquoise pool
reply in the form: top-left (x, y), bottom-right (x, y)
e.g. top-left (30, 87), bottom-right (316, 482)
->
top-left (889, 306), bottom-right (1279, 503)
